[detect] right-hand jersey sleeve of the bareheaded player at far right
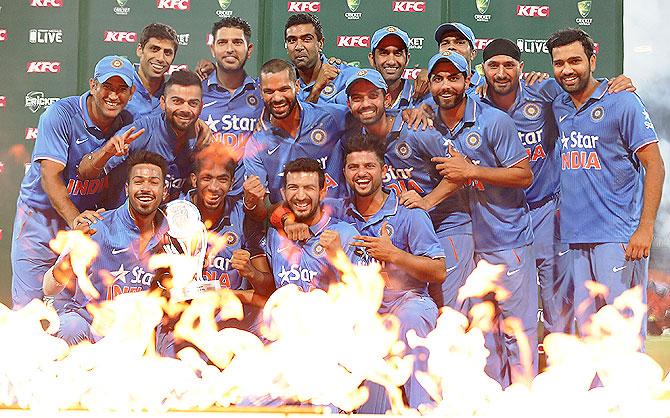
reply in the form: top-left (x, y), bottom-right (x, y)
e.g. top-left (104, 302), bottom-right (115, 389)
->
top-left (617, 92), bottom-right (658, 153)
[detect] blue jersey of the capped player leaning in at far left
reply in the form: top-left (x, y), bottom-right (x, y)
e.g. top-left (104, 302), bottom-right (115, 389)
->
top-left (19, 92), bottom-right (132, 211)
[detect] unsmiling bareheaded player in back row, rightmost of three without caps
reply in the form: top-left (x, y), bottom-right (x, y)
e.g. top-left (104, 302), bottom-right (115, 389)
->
top-left (284, 13), bottom-right (358, 104)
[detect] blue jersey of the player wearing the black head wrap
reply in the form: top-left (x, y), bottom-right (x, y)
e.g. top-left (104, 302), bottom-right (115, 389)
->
top-left (482, 79), bottom-right (563, 204)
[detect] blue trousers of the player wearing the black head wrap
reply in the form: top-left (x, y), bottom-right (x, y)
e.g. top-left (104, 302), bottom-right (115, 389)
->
top-left (529, 196), bottom-right (574, 333)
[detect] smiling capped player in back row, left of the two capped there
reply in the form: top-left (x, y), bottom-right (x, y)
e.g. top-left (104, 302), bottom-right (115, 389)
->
top-left (370, 26), bottom-right (414, 109)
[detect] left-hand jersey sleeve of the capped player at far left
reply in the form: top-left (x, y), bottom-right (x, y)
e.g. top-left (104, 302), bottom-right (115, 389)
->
top-left (33, 102), bottom-right (72, 166)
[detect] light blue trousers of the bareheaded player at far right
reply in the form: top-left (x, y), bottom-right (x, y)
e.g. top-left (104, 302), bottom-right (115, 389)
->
top-left (570, 242), bottom-right (649, 341)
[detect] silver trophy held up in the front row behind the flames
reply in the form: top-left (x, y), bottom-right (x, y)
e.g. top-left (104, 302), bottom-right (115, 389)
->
top-left (163, 200), bottom-right (221, 301)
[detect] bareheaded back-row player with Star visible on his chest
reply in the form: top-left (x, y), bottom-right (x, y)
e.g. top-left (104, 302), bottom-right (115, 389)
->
top-left (200, 16), bottom-right (263, 196)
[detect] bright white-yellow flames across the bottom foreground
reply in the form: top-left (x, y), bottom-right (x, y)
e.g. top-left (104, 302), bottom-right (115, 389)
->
top-left (0, 245), bottom-right (670, 418)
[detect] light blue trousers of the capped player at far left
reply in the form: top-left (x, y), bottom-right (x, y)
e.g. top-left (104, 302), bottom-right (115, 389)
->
top-left (11, 199), bottom-right (67, 309)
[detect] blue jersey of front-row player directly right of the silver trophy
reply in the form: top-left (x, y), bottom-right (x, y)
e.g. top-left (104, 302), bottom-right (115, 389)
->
top-left (184, 190), bottom-right (265, 290)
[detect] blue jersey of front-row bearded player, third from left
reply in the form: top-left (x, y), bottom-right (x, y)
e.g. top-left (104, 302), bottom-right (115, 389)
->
top-left (266, 210), bottom-right (360, 292)
